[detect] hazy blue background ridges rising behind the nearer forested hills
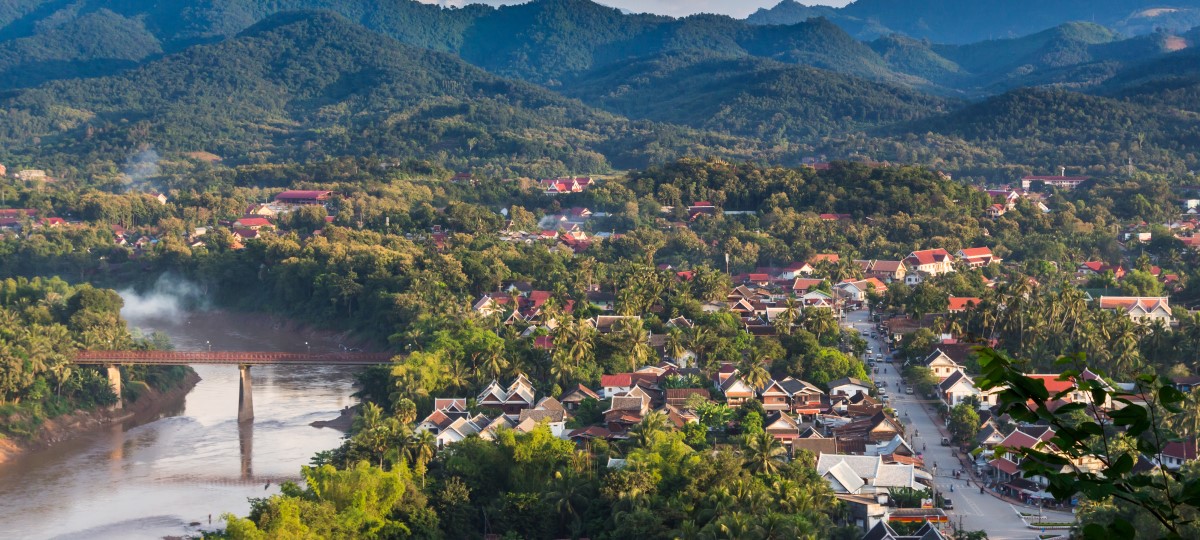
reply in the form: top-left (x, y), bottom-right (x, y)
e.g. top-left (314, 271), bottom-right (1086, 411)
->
top-left (0, 0), bottom-right (1200, 95)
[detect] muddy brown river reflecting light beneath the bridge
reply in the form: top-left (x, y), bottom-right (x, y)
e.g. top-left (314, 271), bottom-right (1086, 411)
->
top-left (0, 312), bottom-right (355, 539)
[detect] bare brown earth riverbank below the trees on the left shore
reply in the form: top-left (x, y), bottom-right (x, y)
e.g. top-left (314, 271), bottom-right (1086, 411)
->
top-left (0, 371), bottom-right (200, 466)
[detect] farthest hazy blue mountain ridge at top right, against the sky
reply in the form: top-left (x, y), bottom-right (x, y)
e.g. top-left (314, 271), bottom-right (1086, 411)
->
top-left (746, 0), bottom-right (1200, 43)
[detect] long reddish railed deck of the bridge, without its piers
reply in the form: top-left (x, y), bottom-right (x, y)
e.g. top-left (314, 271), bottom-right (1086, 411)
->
top-left (74, 350), bottom-right (394, 366)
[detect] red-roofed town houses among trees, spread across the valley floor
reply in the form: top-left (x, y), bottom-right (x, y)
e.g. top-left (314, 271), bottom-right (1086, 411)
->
top-left (0, 159), bottom-right (1200, 539)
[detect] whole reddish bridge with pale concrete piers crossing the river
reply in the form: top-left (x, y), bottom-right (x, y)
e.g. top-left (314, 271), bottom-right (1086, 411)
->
top-left (74, 350), bottom-right (394, 422)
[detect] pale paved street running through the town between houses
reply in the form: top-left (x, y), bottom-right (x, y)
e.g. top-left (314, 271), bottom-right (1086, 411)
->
top-left (844, 310), bottom-right (1074, 540)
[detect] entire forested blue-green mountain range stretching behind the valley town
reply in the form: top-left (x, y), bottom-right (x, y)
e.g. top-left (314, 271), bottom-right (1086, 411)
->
top-left (0, 0), bottom-right (1200, 174)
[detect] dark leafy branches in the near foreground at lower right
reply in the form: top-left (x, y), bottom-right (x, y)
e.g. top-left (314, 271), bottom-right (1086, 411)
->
top-left (976, 349), bottom-right (1200, 539)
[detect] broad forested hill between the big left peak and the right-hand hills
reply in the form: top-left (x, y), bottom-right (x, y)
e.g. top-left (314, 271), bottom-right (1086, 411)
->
top-left (563, 53), bottom-right (956, 144)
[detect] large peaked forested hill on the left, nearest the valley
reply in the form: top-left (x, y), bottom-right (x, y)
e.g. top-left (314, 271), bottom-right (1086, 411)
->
top-left (0, 13), bottom-right (756, 174)
